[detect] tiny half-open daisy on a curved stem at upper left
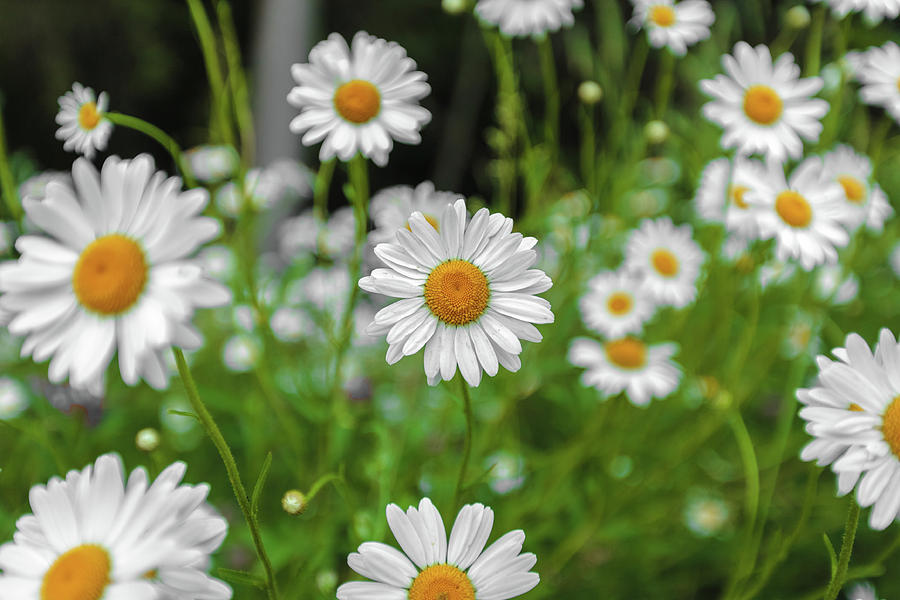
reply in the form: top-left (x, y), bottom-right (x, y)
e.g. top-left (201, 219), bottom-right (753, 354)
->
top-left (56, 81), bottom-right (113, 159)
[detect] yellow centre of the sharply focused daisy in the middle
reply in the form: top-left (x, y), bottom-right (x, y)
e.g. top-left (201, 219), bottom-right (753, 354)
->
top-left (425, 258), bottom-right (491, 325)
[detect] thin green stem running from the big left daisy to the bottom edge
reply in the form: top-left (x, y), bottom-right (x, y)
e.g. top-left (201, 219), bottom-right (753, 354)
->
top-left (172, 347), bottom-right (278, 600)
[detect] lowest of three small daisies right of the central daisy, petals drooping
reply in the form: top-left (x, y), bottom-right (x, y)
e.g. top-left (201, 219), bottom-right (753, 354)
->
top-left (569, 337), bottom-right (681, 406)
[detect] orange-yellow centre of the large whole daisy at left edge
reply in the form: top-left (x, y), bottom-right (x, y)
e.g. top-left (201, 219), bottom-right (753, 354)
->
top-left (72, 233), bottom-right (147, 315)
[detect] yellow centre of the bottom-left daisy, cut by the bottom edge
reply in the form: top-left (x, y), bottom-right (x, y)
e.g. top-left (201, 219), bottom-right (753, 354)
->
top-left (41, 544), bottom-right (112, 600)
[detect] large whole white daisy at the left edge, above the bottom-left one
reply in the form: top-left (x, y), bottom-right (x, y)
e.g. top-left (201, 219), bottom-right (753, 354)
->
top-left (0, 155), bottom-right (230, 388)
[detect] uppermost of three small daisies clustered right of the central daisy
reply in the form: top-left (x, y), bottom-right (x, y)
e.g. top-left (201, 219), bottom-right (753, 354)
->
top-left (625, 217), bottom-right (705, 308)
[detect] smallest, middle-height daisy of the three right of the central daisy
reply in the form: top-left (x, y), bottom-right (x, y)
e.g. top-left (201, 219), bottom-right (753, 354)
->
top-left (578, 270), bottom-right (656, 338)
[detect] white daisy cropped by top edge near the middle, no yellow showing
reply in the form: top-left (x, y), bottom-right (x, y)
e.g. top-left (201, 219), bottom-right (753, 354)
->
top-left (475, 0), bottom-right (584, 36)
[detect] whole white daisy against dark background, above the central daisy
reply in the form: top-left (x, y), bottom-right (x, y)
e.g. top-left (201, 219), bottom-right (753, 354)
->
top-left (288, 31), bottom-right (431, 167)
